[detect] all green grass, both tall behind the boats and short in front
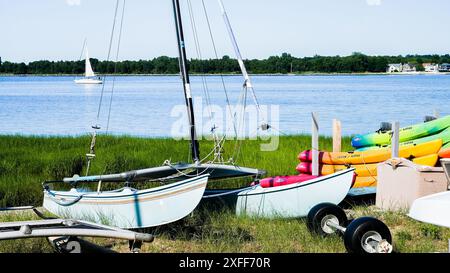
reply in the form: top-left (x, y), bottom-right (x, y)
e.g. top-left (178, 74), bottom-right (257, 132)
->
top-left (0, 136), bottom-right (450, 253)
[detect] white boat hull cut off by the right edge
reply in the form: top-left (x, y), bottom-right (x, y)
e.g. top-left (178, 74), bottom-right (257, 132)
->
top-left (408, 191), bottom-right (450, 228)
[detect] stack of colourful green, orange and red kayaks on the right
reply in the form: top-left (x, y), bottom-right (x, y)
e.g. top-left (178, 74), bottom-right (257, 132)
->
top-left (297, 113), bottom-right (450, 188)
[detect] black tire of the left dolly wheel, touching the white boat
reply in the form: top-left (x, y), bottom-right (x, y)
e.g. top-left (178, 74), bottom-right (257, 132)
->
top-left (307, 203), bottom-right (347, 236)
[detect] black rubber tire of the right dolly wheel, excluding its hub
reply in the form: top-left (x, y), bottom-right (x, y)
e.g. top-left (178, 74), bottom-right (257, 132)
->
top-left (344, 217), bottom-right (392, 254)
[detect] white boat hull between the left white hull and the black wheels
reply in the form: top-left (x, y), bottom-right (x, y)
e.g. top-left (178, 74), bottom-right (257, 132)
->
top-left (236, 169), bottom-right (354, 218)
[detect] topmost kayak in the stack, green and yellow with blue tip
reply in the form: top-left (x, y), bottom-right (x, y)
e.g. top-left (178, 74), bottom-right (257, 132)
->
top-left (352, 116), bottom-right (450, 148)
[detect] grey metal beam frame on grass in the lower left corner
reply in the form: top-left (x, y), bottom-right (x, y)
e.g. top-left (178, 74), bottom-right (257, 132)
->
top-left (0, 206), bottom-right (154, 253)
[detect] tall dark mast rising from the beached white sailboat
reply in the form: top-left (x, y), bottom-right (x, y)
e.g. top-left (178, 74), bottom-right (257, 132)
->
top-left (172, 0), bottom-right (200, 162)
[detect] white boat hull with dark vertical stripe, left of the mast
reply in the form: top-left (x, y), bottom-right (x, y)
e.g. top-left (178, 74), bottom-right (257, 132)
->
top-left (43, 175), bottom-right (208, 229)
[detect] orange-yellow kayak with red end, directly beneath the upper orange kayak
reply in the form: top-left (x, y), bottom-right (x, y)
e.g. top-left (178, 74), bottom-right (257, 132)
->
top-left (297, 154), bottom-right (439, 176)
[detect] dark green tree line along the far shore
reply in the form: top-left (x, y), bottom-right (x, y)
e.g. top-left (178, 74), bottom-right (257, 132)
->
top-left (0, 53), bottom-right (450, 74)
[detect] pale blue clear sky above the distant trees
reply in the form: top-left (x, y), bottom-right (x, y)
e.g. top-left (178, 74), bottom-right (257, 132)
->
top-left (0, 0), bottom-right (450, 62)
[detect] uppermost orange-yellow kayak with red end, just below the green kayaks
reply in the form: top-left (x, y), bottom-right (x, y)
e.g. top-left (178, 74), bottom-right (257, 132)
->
top-left (299, 139), bottom-right (442, 165)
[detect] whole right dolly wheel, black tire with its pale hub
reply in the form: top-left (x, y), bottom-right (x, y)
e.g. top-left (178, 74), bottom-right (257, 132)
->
top-left (344, 217), bottom-right (392, 254)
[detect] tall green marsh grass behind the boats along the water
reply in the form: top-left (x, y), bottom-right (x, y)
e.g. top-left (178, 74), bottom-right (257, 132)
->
top-left (0, 135), bottom-right (350, 207)
